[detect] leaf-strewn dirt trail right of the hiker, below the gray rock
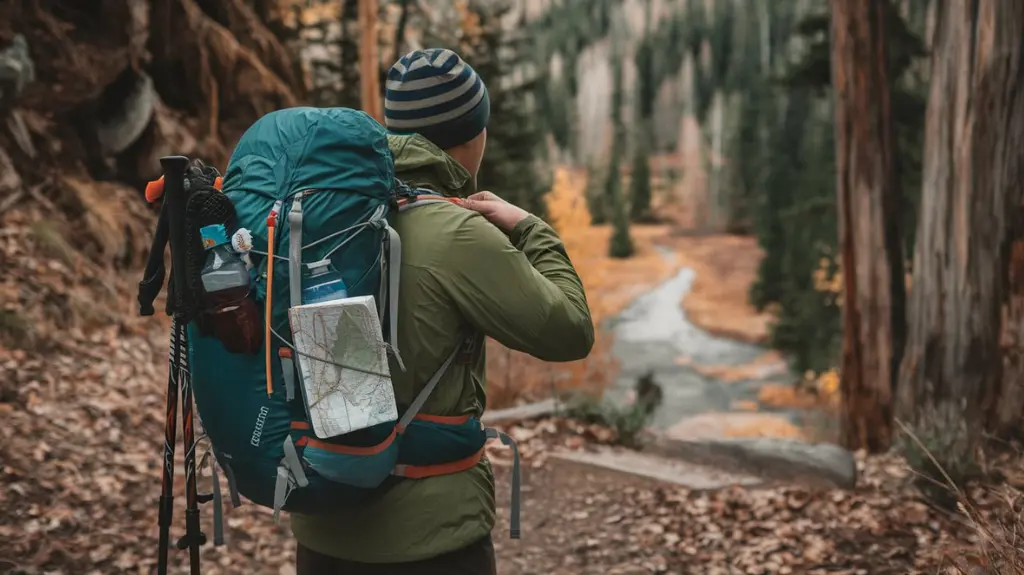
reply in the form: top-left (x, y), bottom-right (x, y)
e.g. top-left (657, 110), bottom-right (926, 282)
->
top-left (494, 433), bottom-right (969, 575)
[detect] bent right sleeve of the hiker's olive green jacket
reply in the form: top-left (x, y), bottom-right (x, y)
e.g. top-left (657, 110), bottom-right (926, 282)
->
top-left (434, 214), bottom-right (594, 361)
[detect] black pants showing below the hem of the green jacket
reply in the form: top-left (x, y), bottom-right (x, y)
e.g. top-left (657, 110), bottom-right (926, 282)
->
top-left (295, 536), bottom-right (498, 575)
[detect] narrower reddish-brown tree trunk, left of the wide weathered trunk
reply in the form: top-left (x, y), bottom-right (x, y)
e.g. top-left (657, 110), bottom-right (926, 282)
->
top-left (831, 0), bottom-right (905, 451)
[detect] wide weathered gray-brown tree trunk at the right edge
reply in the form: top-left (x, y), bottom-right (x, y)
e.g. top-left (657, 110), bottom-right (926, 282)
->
top-left (898, 0), bottom-right (1024, 431)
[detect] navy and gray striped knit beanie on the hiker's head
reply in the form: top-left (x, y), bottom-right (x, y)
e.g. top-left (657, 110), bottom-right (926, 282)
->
top-left (384, 48), bottom-right (490, 149)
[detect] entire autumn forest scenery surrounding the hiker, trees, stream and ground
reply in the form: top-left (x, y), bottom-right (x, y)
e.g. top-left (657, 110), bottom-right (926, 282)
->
top-left (0, 0), bottom-right (1024, 575)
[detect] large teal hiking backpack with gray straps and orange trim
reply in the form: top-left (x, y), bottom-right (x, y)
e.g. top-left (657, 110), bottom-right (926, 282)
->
top-left (188, 107), bottom-right (519, 538)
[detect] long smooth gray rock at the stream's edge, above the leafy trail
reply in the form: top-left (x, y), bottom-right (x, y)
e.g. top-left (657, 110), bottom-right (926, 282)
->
top-left (644, 438), bottom-right (857, 489)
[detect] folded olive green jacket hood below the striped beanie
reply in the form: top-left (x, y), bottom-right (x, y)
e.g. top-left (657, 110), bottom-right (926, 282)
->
top-left (387, 134), bottom-right (474, 197)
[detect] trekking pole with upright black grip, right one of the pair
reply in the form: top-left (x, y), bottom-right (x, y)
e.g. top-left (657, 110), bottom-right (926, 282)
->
top-left (160, 156), bottom-right (206, 575)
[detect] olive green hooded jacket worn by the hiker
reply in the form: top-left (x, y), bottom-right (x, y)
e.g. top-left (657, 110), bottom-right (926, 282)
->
top-left (292, 136), bottom-right (594, 563)
